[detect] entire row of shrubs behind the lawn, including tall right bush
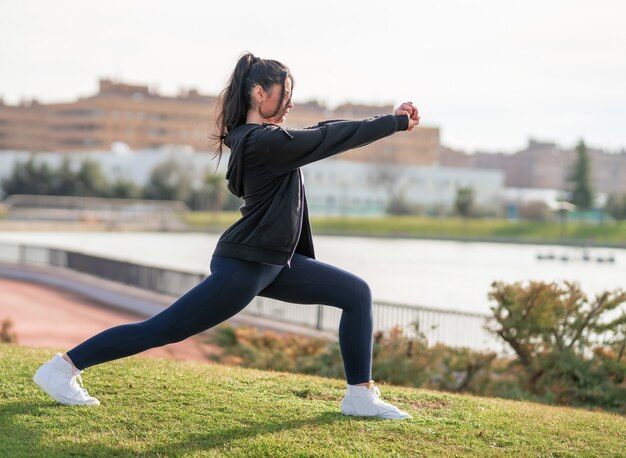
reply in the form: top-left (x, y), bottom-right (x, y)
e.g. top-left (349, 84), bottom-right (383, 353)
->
top-left (205, 282), bottom-right (626, 413)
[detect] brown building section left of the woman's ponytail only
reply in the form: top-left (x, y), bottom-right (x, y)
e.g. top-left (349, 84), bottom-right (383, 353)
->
top-left (0, 79), bottom-right (214, 152)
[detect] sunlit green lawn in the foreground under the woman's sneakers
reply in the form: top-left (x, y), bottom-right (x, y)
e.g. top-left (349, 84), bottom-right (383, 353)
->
top-left (0, 344), bottom-right (626, 457)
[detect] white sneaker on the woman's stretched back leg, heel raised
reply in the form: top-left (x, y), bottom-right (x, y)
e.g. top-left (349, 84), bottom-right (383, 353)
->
top-left (33, 353), bottom-right (100, 406)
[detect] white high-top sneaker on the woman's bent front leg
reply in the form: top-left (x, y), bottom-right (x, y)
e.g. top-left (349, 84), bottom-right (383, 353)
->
top-left (341, 381), bottom-right (413, 420)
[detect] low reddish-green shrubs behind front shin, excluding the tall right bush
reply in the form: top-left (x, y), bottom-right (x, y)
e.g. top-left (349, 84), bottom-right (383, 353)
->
top-left (209, 325), bottom-right (496, 394)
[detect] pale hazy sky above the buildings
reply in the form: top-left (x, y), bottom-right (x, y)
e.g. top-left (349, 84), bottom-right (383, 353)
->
top-left (0, 0), bottom-right (626, 153)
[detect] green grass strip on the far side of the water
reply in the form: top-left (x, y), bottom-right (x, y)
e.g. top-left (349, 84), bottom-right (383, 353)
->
top-left (185, 211), bottom-right (626, 246)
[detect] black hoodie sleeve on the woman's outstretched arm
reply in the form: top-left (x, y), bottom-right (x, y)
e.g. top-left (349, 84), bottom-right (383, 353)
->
top-left (257, 114), bottom-right (409, 175)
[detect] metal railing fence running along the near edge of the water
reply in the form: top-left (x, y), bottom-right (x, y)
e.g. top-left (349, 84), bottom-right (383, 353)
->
top-left (0, 243), bottom-right (512, 356)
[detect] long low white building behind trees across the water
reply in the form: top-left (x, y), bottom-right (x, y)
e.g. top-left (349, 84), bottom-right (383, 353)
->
top-left (0, 145), bottom-right (504, 216)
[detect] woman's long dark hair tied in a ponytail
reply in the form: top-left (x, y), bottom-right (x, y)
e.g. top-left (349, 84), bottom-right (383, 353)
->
top-left (211, 52), bottom-right (294, 165)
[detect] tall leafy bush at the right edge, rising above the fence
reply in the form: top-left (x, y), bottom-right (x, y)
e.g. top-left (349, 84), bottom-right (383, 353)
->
top-left (487, 282), bottom-right (626, 412)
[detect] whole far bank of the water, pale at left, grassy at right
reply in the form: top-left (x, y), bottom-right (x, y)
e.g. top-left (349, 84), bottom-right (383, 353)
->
top-left (0, 211), bottom-right (626, 248)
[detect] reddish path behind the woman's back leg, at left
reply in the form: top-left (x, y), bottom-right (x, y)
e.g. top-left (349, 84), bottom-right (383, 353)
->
top-left (0, 277), bottom-right (219, 362)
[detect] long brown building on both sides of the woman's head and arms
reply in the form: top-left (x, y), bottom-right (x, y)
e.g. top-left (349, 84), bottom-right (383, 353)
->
top-left (0, 79), bottom-right (439, 165)
